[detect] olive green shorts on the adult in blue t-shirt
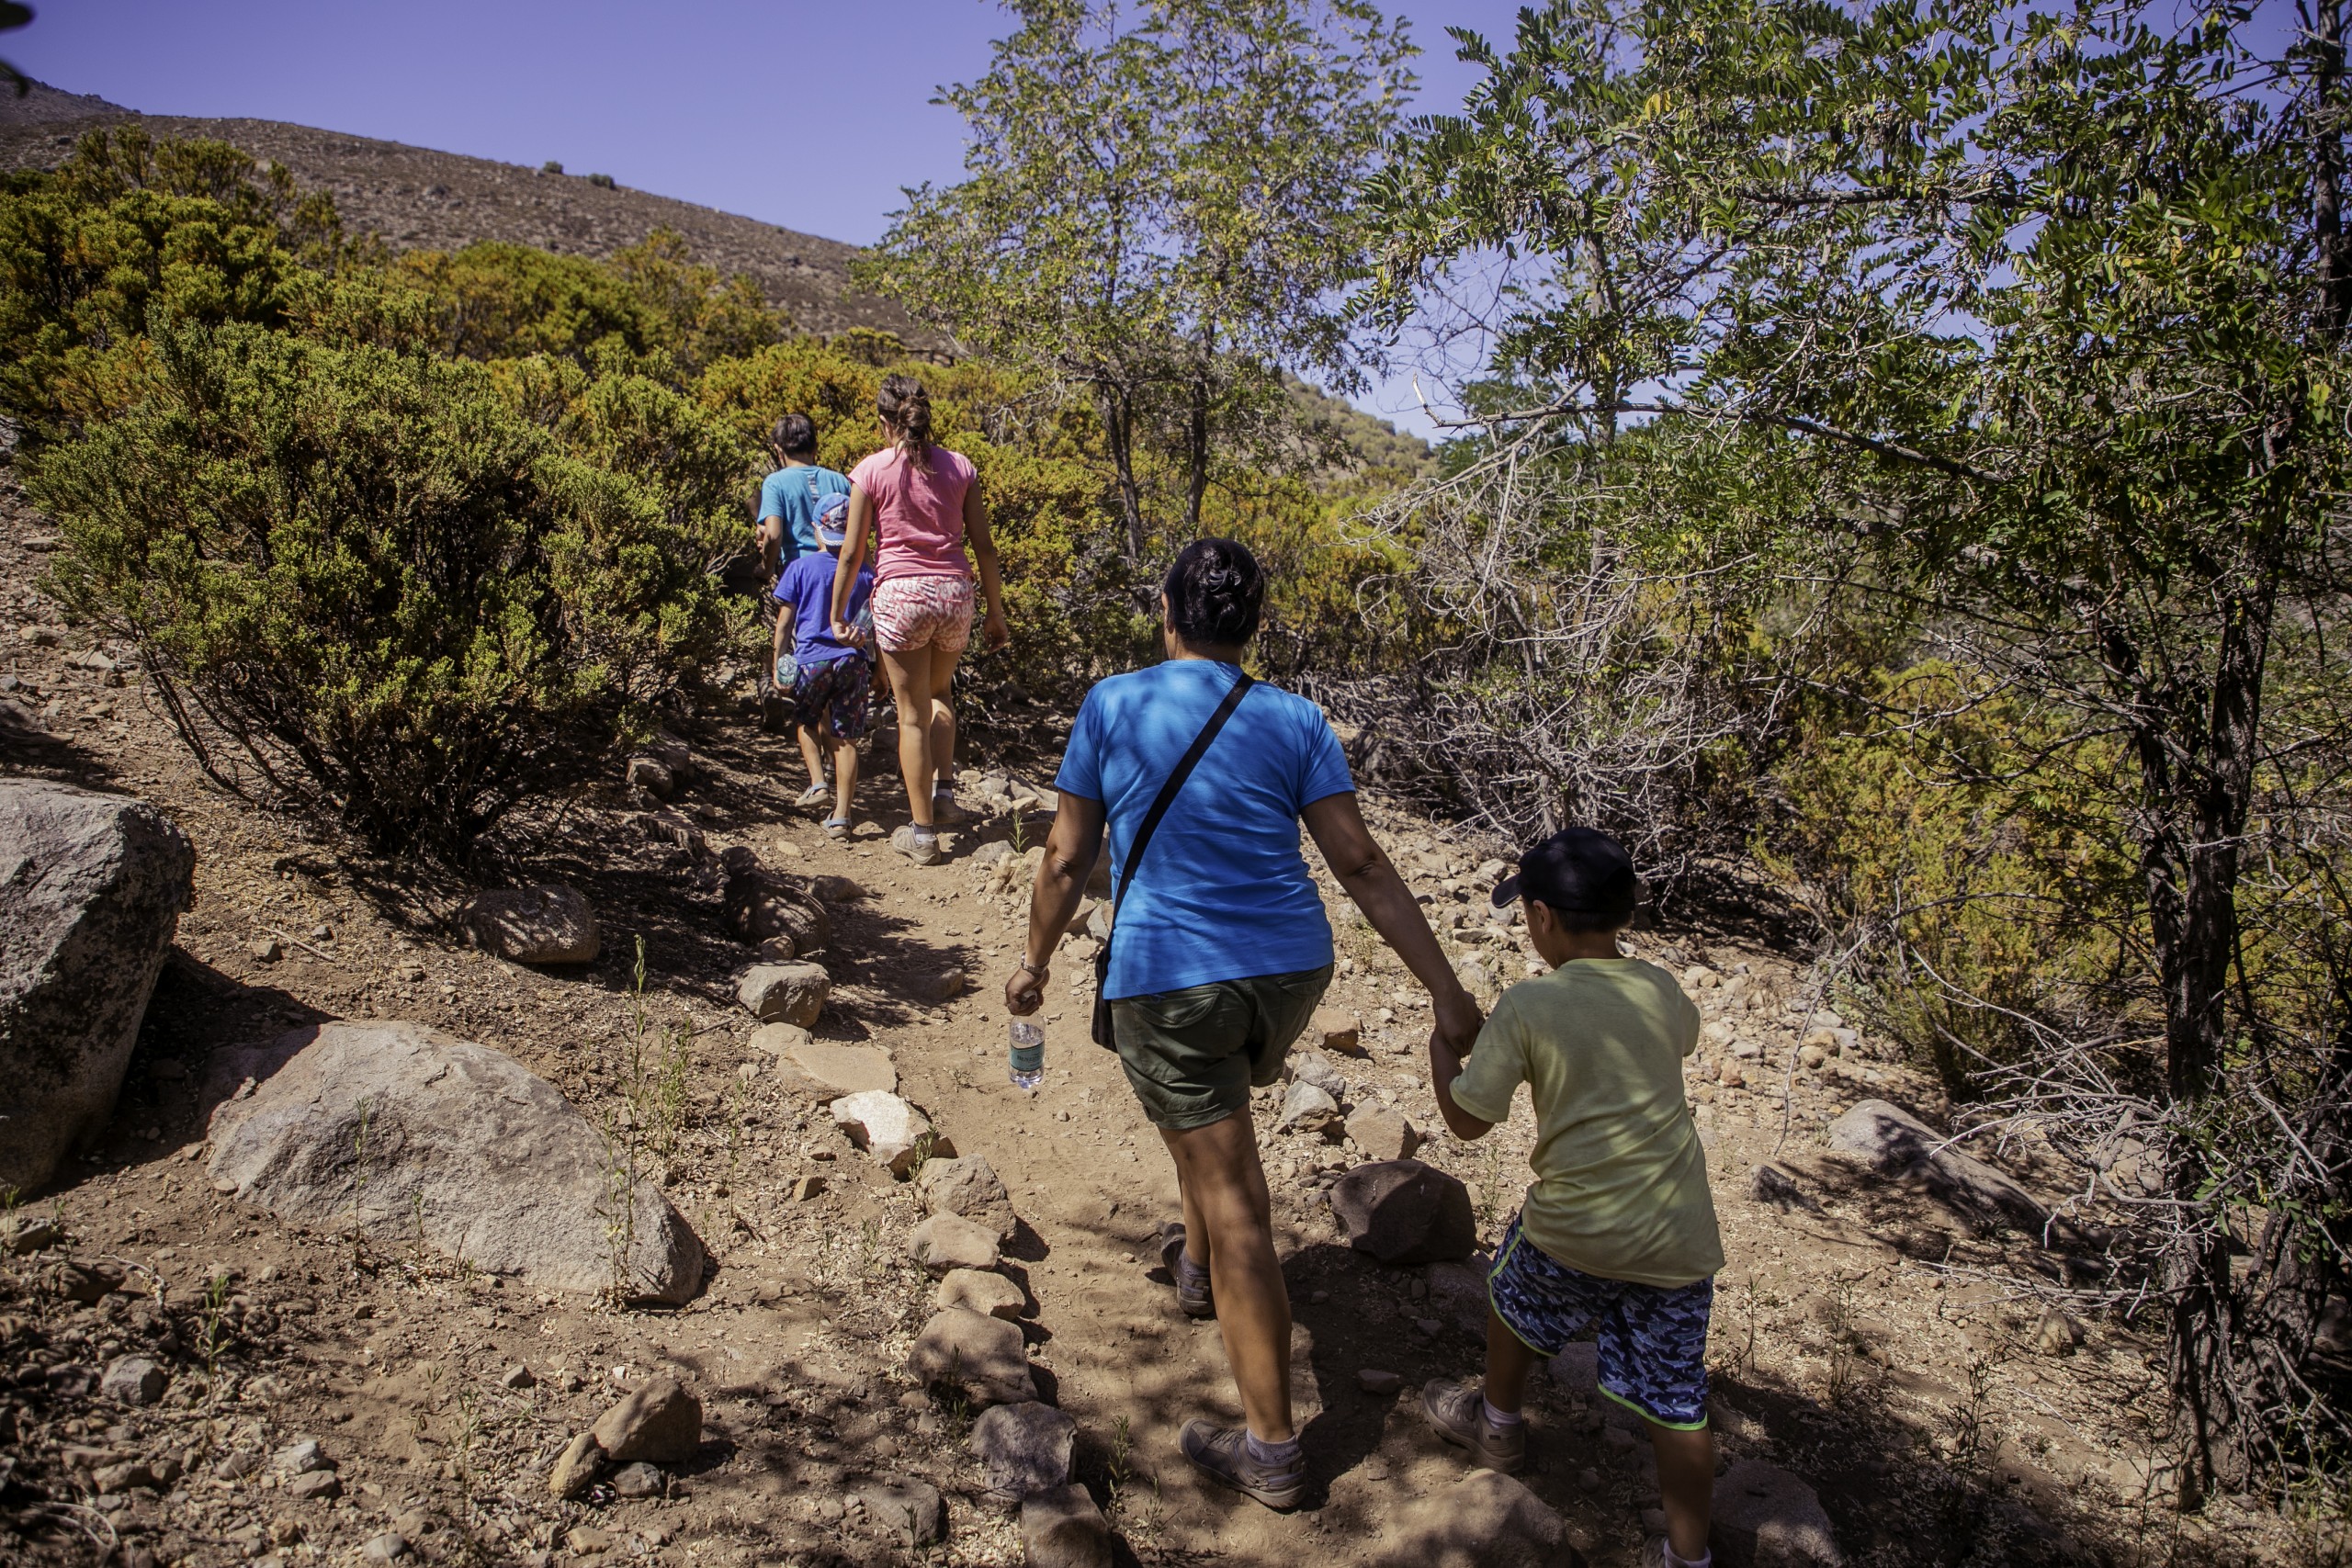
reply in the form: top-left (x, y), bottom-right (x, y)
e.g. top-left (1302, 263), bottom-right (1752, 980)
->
top-left (1110, 964), bottom-right (1331, 1134)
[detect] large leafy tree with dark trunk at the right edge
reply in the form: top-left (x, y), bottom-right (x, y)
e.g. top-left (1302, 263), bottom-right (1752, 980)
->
top-left (1371, 0), bottom-right (2352, 1497)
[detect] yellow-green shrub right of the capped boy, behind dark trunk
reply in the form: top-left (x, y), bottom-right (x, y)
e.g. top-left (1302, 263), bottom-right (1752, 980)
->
top-left (1757, 663), bottom-right (2152, 1098)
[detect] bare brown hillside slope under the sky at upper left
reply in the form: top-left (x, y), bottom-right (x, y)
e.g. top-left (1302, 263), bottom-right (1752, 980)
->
top-left (0, 87), bottom-right (948, 353)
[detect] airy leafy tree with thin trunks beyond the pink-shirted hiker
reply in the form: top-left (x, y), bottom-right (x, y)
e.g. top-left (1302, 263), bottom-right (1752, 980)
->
top-left (861, 0), bottom-right (1411, 559)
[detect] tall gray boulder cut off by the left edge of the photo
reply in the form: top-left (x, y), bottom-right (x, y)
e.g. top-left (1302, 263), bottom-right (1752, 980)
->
top-left (0, 778), bottom-right (195, 1192)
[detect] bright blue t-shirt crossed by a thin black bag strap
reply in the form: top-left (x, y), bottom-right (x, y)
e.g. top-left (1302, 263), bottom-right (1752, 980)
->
top-left (1054, 659), bottom-right (1355, 997)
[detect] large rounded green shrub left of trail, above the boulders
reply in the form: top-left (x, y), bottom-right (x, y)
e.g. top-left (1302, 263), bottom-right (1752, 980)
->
top-left (28, 324), bottom-right (724, 856)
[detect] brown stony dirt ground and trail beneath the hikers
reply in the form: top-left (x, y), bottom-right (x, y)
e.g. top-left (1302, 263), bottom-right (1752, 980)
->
top-left (0, 474), bottom-right (2286, 1568)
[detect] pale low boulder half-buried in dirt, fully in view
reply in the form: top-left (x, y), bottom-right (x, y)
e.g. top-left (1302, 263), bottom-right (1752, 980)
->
top-left (205, 1021), bottom-right (703, 1304)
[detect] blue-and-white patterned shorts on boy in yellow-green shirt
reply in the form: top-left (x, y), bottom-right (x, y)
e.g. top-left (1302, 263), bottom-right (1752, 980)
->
top-left (1487, 1215), bottom-right (1714, 1432)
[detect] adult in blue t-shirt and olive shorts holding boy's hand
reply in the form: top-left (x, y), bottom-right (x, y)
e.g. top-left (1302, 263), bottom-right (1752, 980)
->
top-left (1004, 538), bottom-right (1479, 1509)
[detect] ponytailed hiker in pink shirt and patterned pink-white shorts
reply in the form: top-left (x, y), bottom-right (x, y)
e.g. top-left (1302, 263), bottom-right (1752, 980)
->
top-left (832, 376), bottom-right (1012, 865)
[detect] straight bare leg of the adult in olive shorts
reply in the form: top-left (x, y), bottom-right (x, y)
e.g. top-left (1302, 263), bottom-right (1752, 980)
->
top-left (1159, 1112), bottom-right (1294, 1443)
